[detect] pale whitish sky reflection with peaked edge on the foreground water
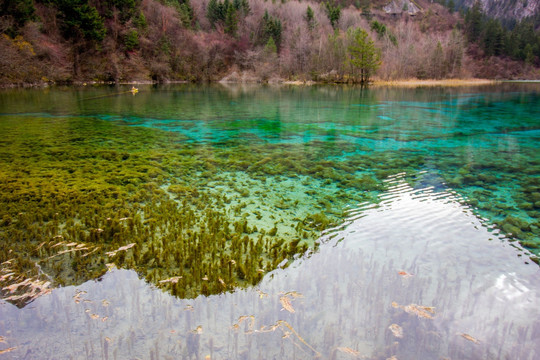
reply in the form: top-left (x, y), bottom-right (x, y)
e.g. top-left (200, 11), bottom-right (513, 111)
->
top-left (0, 174), bottom-right (540, 360)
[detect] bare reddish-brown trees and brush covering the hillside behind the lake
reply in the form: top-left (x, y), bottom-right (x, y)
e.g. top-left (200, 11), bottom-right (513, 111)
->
top-left (0, 0), bottom-right (540, 83)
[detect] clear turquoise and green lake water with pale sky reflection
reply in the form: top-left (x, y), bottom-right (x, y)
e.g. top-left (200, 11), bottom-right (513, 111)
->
top-left (0, 84), bottom-right (540, 359)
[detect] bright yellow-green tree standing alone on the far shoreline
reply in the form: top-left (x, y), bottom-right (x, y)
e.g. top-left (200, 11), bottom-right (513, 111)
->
top-left (347, 29), bottom-right (381, 84)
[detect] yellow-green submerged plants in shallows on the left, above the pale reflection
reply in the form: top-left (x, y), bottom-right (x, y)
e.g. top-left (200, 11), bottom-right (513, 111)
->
top-left (0, 112), bottom-right (410, 306)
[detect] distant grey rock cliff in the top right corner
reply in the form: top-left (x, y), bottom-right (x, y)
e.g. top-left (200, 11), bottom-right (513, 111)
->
top-left (463, 0), bottom-right (540, 21)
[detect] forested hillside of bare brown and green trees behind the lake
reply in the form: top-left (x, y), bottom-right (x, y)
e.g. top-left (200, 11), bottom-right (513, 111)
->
top-left (0, 0), bottom-right (540, 84)
